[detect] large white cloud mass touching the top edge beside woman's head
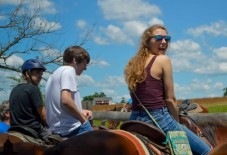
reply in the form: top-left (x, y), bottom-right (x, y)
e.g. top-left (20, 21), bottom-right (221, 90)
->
top-left (93, 0), bottom-right (163, 45)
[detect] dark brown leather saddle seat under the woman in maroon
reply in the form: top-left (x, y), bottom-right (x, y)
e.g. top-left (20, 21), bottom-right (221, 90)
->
top-left (120, 120), bottom-right (166, 147)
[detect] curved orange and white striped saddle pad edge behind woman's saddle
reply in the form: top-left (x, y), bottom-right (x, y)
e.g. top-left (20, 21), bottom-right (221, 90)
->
top-left (111, 130), bottom-right (150, 155)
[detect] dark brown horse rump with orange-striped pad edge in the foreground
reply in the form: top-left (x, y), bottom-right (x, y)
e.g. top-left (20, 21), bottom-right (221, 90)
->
top-left (44, 130), bottom-right (153, 155)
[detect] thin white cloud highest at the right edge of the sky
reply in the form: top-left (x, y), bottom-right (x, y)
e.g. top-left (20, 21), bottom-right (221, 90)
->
top-left (187, 20), bottom-right (227, 36)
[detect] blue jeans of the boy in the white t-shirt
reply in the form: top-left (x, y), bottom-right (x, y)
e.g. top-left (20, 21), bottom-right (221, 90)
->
top-left (62, 121), bottom-right (93, 138)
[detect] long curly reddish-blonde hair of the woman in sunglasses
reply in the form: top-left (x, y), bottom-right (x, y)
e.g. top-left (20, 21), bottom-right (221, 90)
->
top-left (125, 24), bottom-right (168, 90)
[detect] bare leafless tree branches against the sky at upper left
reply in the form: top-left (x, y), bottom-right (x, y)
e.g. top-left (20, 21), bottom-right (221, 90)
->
top-left (0, 1), bottom-right (61, 71)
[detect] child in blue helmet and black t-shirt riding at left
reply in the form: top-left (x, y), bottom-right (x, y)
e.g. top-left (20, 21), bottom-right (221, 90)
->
top-left (9, 59), bottom-right (50, 141)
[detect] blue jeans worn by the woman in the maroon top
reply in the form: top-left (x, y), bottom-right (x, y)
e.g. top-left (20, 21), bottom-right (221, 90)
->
top-left (129, 108), bottom-right (211, 155)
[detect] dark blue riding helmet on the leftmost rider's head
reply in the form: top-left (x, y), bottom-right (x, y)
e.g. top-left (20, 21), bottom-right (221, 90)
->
top-left (21, 59), bottom-right (46, 74)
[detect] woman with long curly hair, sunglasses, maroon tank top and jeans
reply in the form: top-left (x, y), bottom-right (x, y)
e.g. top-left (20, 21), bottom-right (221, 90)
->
top-left (125, 25), bottom-right (211, 155)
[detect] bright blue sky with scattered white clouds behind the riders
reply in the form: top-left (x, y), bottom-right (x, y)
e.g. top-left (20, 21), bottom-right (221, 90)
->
top-left (0, 0), bottom-right (227, 102)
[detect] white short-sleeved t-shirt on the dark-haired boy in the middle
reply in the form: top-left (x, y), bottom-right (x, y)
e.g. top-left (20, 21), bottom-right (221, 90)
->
top-left (45, 66), bottom-right (82, 135)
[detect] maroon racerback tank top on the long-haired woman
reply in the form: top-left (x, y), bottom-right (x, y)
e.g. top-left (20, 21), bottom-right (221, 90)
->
top-left (130, 56), bottom-right (166, 110)
